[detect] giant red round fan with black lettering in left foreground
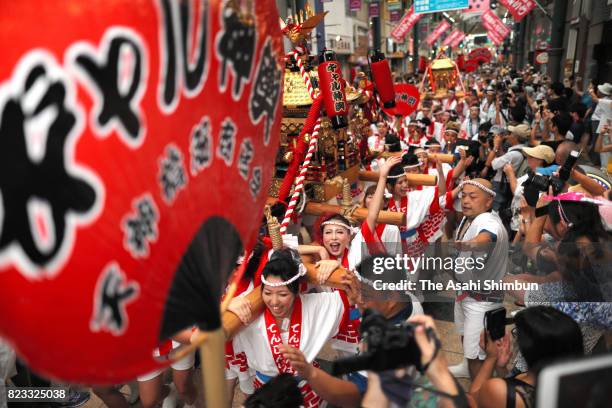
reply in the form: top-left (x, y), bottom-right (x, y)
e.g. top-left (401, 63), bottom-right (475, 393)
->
top-left (0, 0), bottom-right (284, 384)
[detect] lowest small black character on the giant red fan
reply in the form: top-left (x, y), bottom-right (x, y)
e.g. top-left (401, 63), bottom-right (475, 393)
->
top-left (91, 263), bottom-right (139, 336)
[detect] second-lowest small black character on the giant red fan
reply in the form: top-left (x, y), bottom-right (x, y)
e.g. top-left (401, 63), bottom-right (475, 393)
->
top-left (123, 195), bottom-right (159, 257)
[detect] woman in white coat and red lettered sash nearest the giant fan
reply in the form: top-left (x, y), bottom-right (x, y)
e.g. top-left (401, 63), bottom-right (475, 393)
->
top-left (233, 248), bottom-right (356, 407)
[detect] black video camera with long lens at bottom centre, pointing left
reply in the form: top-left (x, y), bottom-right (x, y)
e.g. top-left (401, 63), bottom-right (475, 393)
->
top-left (331, 309), bottom-right (424, 376)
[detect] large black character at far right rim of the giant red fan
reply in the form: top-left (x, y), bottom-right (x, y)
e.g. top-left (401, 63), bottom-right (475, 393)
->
top-left (249, 39), bottom-right (281, 145)
